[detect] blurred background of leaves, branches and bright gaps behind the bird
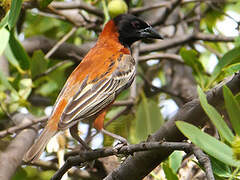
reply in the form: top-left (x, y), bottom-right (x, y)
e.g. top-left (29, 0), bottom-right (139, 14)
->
top-left (0, 0), bottom-right (240, 179)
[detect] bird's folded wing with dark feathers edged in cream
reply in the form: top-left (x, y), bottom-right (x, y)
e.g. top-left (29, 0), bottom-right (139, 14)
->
top-left (58, 54), bottom-right (136, 130)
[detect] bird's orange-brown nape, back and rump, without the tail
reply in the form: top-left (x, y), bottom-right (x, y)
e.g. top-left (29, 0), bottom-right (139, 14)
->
top-left (49, 21), bottom-right (130, 128)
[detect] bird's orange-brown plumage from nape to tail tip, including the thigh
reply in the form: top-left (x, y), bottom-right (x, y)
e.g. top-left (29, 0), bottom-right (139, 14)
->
top-left (24, 21), bottom-right (130, 161)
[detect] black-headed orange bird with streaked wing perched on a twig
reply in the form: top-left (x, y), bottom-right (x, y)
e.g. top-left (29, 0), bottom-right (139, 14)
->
top-left (23, 14), bottom-right (162, 162)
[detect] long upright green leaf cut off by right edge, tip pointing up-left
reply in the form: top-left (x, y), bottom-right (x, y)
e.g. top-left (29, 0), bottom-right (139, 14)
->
top-left (223, 86), bottom-right (240, 135)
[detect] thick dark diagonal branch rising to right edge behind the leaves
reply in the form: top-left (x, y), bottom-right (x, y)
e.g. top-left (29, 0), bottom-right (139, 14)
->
top-left (105, 73), bottom-right (240, 180)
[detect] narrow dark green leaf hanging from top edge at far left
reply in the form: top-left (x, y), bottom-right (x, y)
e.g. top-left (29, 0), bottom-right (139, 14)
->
top-left (8, 0), bottom-right (22, 29)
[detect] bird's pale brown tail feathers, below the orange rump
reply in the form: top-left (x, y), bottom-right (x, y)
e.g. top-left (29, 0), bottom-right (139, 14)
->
top-left (23, 126), bottom-right (57, 162)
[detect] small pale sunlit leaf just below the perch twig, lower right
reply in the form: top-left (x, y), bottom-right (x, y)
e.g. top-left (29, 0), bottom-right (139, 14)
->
top-left (169, 151), bottom-right (183, 173)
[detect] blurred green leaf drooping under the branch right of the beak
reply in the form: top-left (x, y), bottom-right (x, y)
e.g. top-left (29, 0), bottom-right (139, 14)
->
top-left (180, 48), bottom-right (206, 87)
